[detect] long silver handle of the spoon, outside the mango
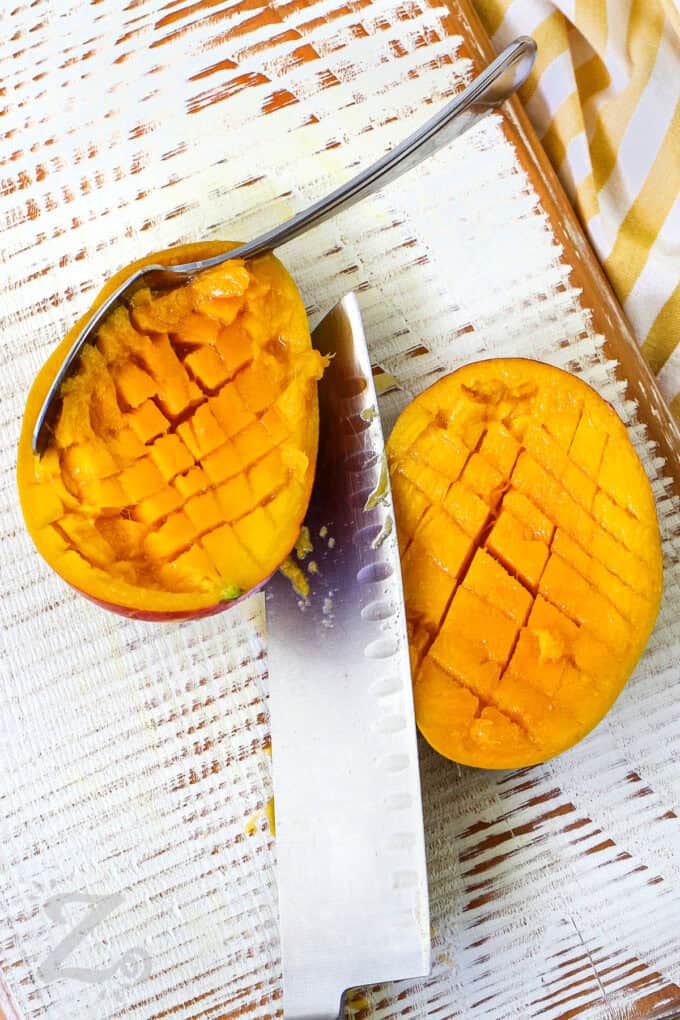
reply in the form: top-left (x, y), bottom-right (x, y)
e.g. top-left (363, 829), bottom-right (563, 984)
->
top-left (196, 36), bottom-right (536, 267)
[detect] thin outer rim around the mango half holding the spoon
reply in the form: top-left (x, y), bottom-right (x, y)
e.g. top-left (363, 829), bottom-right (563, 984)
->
top-left (16, 241), bottom-right (318, 622)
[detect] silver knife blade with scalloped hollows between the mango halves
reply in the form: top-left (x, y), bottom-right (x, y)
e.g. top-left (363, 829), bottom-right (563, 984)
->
top-left (266, 294), bottom-right (430, 1020)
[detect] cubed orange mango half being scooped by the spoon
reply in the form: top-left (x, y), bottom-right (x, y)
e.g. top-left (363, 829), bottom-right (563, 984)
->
top-left (17, 243), bottom-right (324, 617)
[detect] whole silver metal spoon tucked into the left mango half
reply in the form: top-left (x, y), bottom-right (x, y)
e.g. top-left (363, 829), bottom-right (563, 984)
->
top-left (32, 36), bottom-right (536, 454)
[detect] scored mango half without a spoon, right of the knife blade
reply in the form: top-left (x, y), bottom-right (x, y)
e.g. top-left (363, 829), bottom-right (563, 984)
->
top-left (387, 359), bottom-right (662, 768)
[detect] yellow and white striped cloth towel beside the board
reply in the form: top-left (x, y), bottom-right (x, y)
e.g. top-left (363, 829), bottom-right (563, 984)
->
top-left (475, 0), bottom-right (680, 419)
